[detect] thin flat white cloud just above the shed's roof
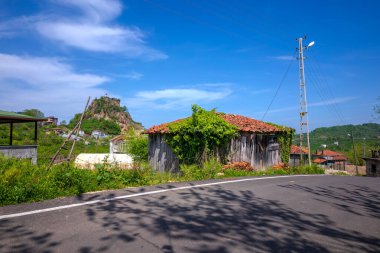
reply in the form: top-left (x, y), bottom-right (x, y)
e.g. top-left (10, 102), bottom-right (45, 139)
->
top-left (127, 88), bottom-right (231, 109)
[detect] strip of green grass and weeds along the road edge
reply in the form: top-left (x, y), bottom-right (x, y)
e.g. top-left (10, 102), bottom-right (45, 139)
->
top-left (0, 157), bottom-right (324, 206)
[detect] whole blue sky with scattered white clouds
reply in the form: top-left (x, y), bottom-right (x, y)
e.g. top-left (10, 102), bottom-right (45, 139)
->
top-left (0, 0), bottom-right (380, 129)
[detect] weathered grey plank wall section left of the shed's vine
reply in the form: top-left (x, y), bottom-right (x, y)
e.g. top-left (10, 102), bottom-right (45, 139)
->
top-left (148, 134), bottom-right (179, 172)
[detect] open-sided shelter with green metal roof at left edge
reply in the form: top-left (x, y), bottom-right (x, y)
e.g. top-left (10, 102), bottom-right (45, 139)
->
top-left (0, 110), bottom-right (47, 163)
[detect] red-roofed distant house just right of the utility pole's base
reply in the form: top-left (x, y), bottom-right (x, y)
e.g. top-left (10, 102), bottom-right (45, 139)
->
top-left (312, 149), bottom-right (347, 170)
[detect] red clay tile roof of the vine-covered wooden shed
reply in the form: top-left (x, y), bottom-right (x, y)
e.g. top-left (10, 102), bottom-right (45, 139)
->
top-left (146, 114), bottom-right (283, 134)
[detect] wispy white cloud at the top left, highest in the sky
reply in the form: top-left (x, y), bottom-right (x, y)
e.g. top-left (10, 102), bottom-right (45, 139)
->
top-left (0, 0), bottom-right (168, 60)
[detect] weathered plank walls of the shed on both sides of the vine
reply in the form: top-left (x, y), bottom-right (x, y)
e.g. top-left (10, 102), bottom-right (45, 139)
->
top-left (149, 133), bottom-right (281, 172)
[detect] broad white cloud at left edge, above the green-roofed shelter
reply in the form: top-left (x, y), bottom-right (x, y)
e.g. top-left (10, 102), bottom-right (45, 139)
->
top-left (0, 54), bottom-right (109, 119)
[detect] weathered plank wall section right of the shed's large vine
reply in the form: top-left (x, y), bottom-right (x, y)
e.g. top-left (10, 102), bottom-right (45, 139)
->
top-left (228, 133), bottom-right (281, 169)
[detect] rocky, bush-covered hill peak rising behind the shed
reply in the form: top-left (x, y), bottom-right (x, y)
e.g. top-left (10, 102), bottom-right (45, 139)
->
top-left (69, 96), bottom-right (144, 135)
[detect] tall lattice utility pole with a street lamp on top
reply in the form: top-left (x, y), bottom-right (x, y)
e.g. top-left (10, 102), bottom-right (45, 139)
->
top-left (297, 36), bottom-right (314, 166)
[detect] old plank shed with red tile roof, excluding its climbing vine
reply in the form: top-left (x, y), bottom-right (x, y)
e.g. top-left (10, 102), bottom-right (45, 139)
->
top-left (146, 114), bottom-right (290, 172)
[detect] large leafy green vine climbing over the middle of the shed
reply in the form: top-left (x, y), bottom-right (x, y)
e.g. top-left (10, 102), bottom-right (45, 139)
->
top-left (165, 105), bottom-right (237, 164)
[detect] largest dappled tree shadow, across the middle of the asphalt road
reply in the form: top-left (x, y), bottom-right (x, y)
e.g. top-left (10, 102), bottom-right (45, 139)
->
top-left (79, 186), bottom-right (380, 253)
